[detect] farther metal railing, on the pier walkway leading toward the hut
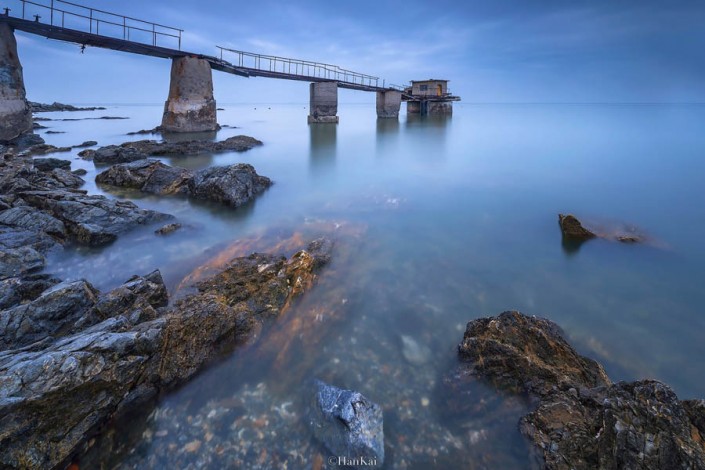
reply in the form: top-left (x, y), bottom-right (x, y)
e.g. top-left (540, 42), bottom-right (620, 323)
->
top-left (216, 46), bottom-right (379, 87)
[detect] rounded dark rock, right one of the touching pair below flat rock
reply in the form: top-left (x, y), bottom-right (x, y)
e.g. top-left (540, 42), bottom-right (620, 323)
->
top-left (189, 163), bottom-right (272, 207)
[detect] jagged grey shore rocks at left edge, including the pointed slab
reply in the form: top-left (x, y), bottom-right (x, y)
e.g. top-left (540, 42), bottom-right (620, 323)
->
top-left (0, 154), bottom-right (171, 252)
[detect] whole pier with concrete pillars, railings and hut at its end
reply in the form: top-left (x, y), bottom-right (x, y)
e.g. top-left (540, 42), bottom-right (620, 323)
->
top-left (0, 0), bottom-right (460, 140)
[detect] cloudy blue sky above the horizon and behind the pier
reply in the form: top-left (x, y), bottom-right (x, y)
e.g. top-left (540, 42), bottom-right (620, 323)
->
top-left (2, 0), bottom-right (705, 103)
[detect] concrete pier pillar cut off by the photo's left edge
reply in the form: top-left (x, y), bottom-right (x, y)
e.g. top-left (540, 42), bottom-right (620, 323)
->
top-left (0, 23), bottom-right (32, 141)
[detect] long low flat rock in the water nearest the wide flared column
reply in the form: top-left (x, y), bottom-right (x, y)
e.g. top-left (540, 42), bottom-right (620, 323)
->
top-left (78, 135), bottom-right (262, 165)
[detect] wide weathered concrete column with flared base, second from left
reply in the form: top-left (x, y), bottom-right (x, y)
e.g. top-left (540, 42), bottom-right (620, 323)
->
top-left (162, 57), bottom-right (218, 132)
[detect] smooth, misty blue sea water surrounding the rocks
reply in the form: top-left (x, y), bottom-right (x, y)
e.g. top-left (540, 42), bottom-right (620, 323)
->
top-left (33, 104), bottom-right (705, 468)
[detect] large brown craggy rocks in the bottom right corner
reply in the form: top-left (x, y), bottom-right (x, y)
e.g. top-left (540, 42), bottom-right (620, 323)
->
top-left (452, 312), bottom-right (705, 470)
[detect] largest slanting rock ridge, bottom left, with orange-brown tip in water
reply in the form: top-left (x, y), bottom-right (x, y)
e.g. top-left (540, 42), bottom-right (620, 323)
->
top-left (0, 243), bottom-right (330, 468)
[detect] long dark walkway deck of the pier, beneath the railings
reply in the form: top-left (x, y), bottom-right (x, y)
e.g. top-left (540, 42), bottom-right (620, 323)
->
top-left (0, 14), bottom-right (395, 92)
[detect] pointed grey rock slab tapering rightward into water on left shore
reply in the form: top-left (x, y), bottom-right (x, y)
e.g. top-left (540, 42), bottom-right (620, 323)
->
top-left (20, 190), bottom-right (172, 246)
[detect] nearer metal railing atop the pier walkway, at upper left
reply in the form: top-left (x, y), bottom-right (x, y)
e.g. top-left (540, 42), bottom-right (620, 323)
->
top-left (3, 0), bottom-right (183, 50)
